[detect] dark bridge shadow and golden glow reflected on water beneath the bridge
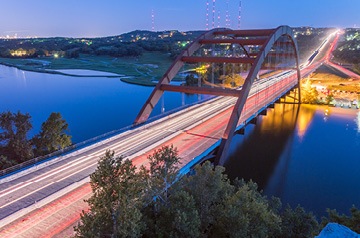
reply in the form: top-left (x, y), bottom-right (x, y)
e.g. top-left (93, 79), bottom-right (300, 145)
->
top-left (225, 104), bottom-right (314, 189)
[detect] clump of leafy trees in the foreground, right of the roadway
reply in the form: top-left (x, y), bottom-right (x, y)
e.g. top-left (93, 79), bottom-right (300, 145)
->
top-left (75, 146), bottom-right (318, 237)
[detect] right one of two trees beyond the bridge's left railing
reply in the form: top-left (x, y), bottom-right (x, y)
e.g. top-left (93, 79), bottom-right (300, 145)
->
top-left (32, 112), bottom-right (71, 156)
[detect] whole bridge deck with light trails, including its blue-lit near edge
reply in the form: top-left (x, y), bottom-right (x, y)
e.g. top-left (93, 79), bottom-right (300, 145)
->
top-left (0, 71), bottom-right (296, 235)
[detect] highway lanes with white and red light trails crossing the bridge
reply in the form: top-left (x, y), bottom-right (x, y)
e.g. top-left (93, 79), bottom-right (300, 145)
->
top-left (0, 29), bottom-right (338, 237)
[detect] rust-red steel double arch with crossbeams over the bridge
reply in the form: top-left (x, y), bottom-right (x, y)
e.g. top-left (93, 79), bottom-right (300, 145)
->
top-left (134, 26), bottom-right (301, 165)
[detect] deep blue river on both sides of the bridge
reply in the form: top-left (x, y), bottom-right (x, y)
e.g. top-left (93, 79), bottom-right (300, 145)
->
top-left (0, 65), bottom-right (360, 217)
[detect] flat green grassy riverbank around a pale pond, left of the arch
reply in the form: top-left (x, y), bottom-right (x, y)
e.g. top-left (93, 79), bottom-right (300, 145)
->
top-left (0, 52), bottom-right (172, 86)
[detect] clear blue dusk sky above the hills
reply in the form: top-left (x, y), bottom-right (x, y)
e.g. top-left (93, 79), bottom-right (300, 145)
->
top-left (0, 0), bottom-right (360, 37)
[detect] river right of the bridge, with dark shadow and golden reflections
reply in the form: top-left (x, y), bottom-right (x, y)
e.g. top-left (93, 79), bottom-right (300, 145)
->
top-left (225, 105), bottom-right (360, 217)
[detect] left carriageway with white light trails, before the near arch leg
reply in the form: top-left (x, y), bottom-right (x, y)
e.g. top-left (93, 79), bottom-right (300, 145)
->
top-left (0, 98), bottom-right (234, 219)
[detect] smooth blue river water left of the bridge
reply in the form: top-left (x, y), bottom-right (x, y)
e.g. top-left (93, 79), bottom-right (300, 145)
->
top-left (0, 65), bottom-right (207, 143)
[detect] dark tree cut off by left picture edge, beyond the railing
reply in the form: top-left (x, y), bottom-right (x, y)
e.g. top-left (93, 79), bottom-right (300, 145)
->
top-left (0, 111), bottom-right (33, 163)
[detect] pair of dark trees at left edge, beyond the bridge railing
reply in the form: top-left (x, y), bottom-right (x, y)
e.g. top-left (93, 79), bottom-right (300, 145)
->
top-left (0, 111), bottom-right (71, 169)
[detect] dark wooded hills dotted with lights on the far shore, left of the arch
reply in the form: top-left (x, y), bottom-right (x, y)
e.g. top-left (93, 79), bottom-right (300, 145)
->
top-left (0, 31), bottom-right (201, 58)
